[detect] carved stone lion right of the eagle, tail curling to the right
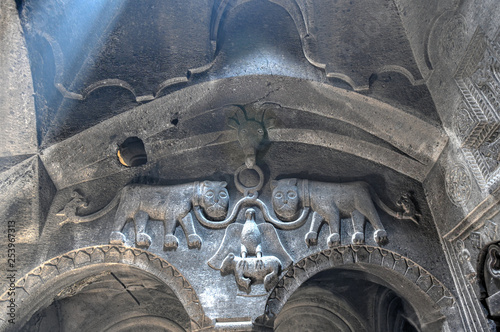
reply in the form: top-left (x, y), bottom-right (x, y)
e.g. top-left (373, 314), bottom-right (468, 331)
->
top-left (271, 179), bottom-right (419, 247)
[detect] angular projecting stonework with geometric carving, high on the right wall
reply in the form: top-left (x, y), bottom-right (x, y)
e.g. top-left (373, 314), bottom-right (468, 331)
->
top-left (455, 29), bottom-right (500, 191)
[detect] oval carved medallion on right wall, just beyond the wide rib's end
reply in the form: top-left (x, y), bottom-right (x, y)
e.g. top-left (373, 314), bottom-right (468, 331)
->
top-left (445, 164), bottom-right (472, 206)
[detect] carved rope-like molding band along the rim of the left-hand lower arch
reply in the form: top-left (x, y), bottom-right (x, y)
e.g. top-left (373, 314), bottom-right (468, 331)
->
top-left (0, 245), bottom-right (212, 331)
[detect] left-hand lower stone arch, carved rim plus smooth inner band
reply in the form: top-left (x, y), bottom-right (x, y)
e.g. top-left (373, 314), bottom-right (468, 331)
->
top-left (0, 245), bottom-right (212, 330)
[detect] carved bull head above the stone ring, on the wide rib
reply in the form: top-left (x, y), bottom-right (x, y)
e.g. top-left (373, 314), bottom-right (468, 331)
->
top-left (228, 104), bottom-right (275, 168)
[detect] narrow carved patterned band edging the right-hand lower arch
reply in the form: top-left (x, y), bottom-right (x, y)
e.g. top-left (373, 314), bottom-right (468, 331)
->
top-left (266, 245), bottom-right (455, 318)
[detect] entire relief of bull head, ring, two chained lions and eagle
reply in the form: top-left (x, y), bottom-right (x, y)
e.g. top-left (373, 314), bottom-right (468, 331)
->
top-left (57, 112), bottom-right (420, 296)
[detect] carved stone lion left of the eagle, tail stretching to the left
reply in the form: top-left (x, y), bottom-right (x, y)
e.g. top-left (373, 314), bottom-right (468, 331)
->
top-left (58, 181), bottom-right (229, 250)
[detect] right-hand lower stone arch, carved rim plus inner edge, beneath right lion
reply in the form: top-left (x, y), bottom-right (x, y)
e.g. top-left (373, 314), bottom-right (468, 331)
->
top-left (264, 245), bottom-right (455, 331)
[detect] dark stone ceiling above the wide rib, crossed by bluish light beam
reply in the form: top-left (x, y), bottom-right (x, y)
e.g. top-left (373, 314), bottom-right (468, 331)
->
top-left (20, 0), bottom-right (440, 147)
